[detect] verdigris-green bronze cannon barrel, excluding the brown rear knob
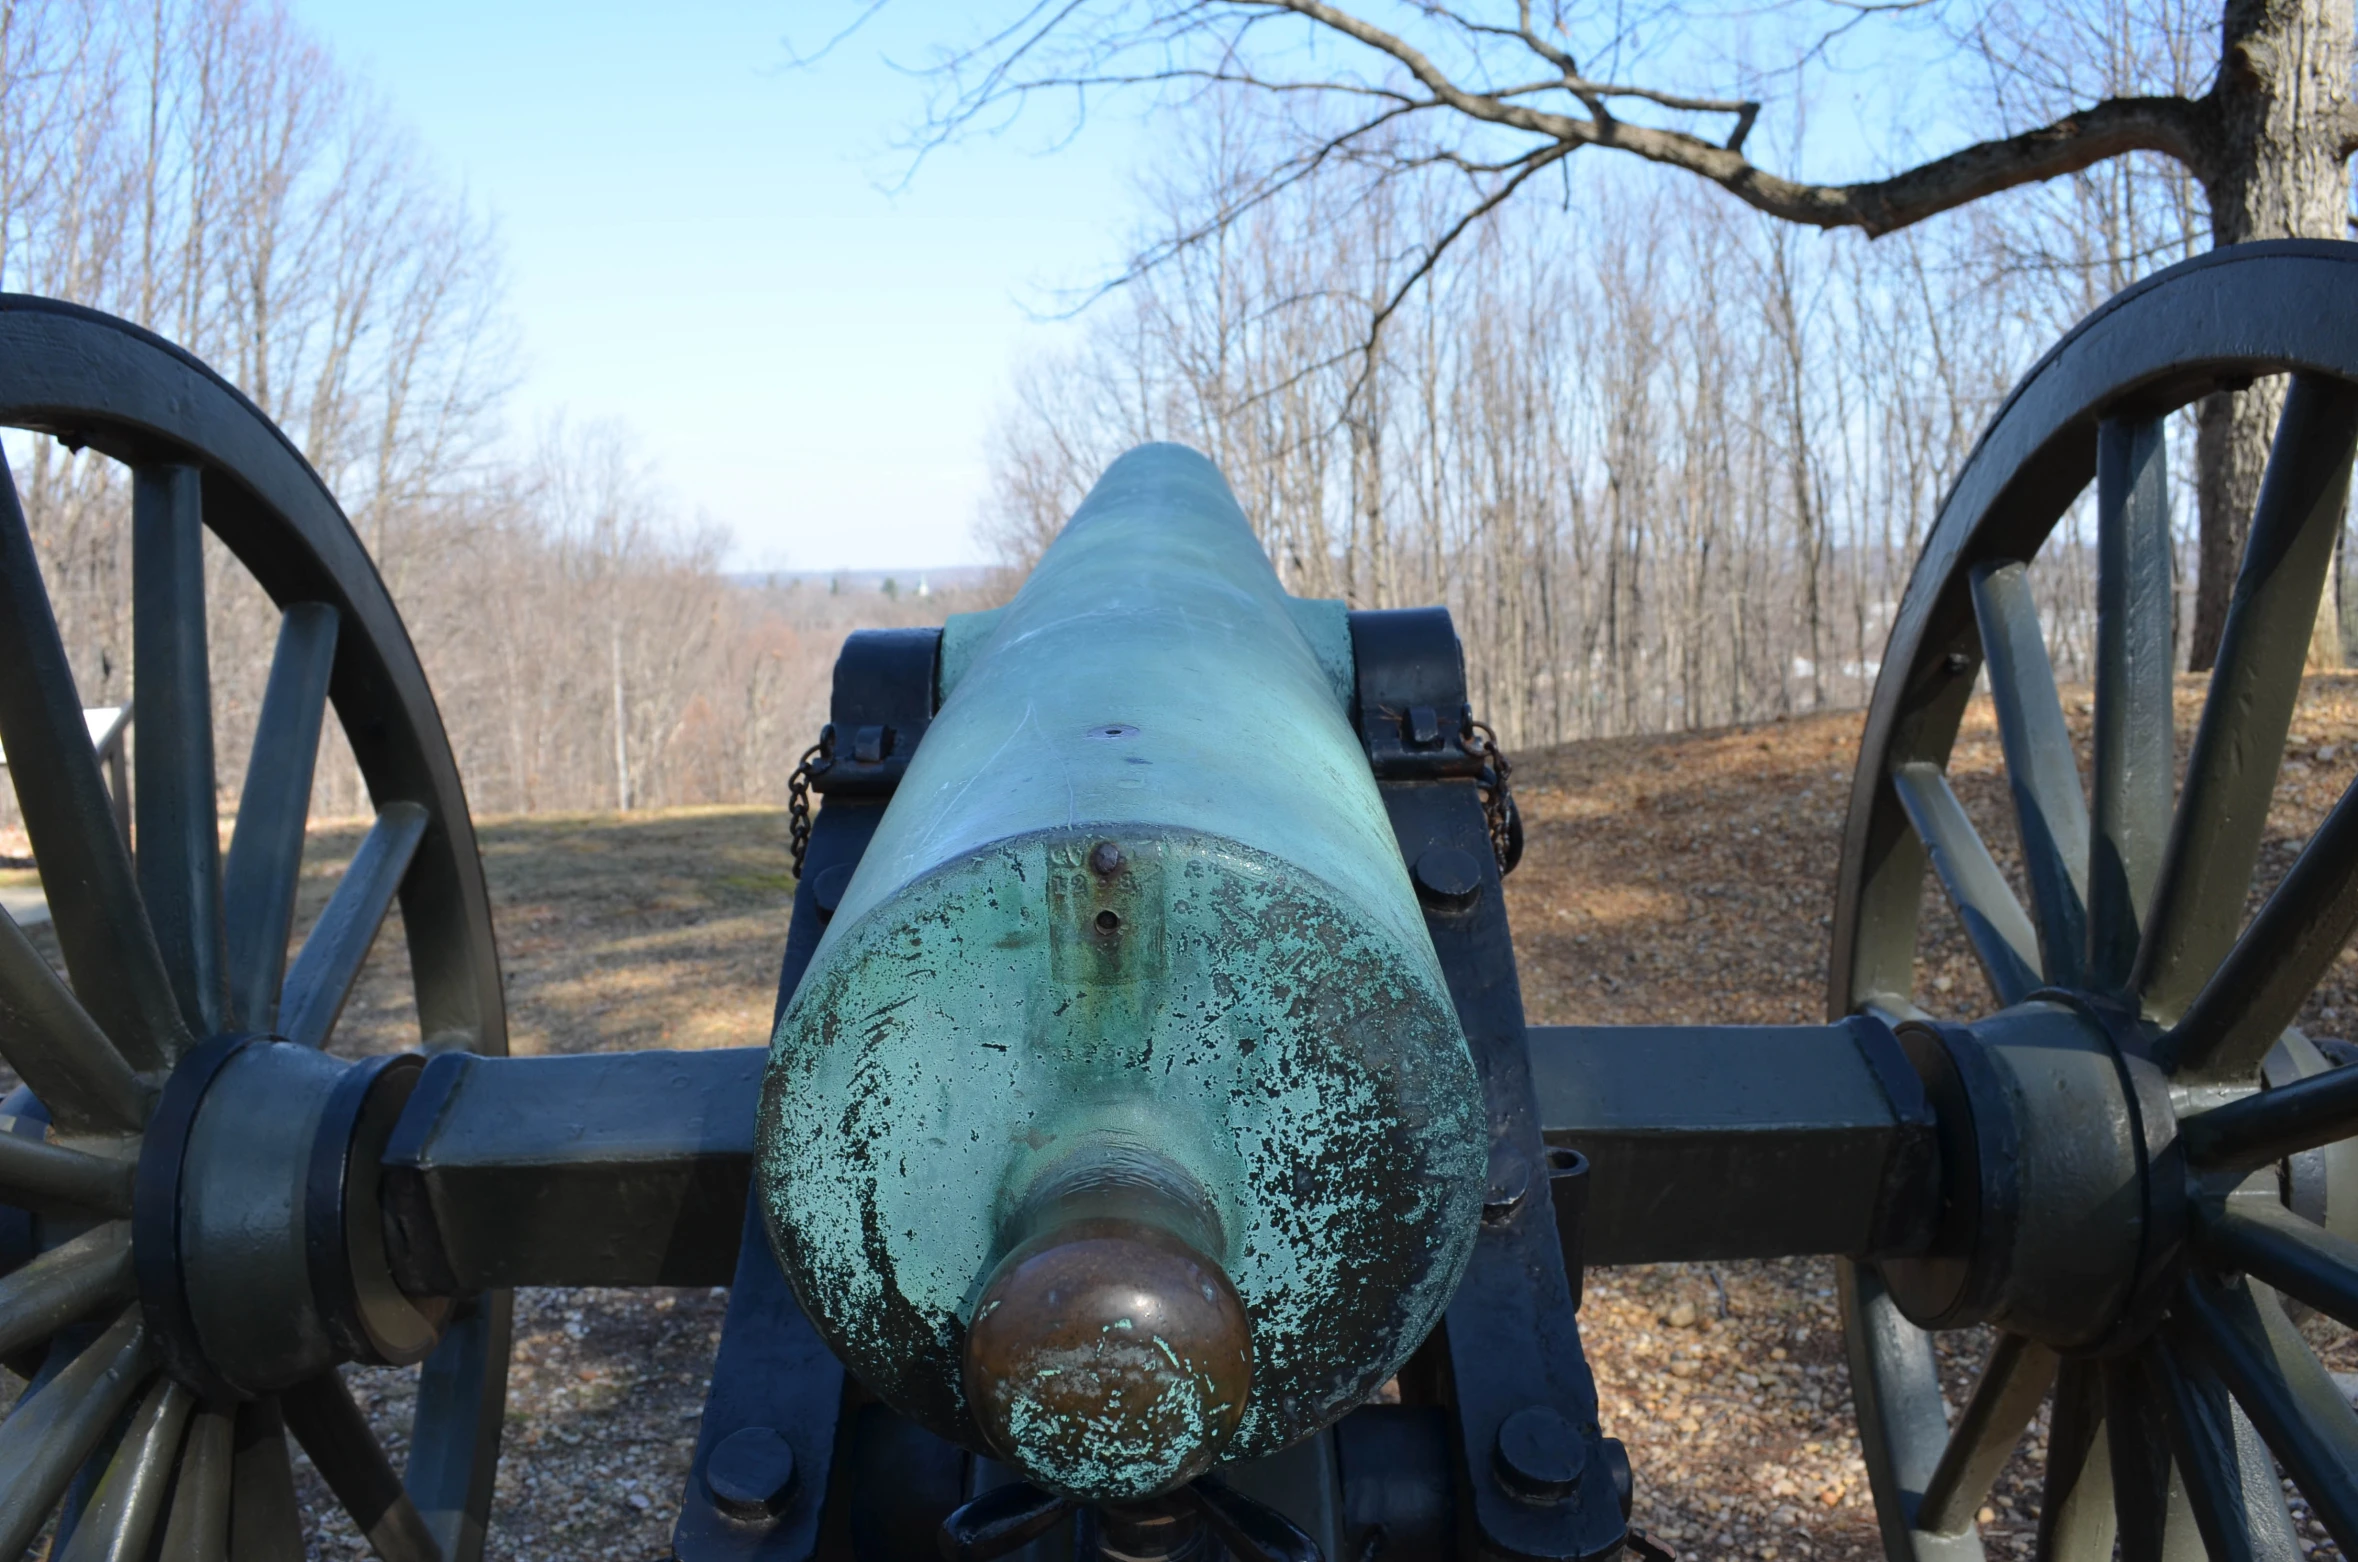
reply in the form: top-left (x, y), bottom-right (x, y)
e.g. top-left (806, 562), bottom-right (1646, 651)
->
top-left (759, 446), bottom-right (1486, 1496)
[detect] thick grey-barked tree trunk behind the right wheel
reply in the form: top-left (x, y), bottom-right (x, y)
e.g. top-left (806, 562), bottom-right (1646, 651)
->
top-left (2188, 0), bottom-right (2351, 670)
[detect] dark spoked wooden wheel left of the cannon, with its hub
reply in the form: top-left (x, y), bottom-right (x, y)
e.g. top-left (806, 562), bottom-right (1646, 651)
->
top-left (0, 297), bottom-right (509, 1562)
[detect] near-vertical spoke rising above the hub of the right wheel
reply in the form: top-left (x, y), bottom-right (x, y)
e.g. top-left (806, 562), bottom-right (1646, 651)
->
top-left (2087, 418), bottom-right (2176, 991)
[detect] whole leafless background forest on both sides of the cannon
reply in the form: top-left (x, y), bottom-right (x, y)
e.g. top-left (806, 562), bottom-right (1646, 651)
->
top-left (0, 0), bottom-right (2348, 830)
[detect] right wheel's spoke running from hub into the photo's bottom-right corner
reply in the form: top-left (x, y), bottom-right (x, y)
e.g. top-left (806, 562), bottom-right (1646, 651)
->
top-left (2172, 1279), bottom-right (2358, 1553)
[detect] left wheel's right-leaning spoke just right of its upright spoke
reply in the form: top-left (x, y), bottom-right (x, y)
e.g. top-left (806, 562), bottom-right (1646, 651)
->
top-left (222, 602), bottom-right (337, 1031)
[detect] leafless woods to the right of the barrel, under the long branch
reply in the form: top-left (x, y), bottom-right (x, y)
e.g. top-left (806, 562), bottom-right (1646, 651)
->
top-left (990, 30), bottom-right (2282, 746)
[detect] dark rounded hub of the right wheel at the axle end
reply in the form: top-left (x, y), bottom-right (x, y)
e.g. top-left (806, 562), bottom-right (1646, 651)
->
top-left (1884, 991), bottom-right (2186, 1352)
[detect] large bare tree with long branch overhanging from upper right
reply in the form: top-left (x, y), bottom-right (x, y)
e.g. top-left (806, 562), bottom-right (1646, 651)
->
top-left (920, 0), bottom-right (2358, 668)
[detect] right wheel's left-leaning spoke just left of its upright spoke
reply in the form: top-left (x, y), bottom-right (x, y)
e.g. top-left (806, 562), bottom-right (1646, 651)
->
top-left (1974, 564), bottom-right (2087, 984)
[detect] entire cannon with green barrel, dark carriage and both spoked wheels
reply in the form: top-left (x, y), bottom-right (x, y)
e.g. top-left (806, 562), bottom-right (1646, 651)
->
top-left (0, 243), bottom-right (2358, 1562)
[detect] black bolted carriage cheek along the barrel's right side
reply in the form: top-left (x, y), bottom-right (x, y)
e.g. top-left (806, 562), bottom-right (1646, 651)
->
top-left (1344, 609), bottom-right (1629, 1562)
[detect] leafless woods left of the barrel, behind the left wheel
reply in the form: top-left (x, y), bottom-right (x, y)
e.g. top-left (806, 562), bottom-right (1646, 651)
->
top-left (0, 0), bottom-right (995, 830)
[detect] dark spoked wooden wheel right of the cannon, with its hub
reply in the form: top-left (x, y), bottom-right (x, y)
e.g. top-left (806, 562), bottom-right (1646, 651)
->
top-left (1830, 243), bottom-right (2358, 1562)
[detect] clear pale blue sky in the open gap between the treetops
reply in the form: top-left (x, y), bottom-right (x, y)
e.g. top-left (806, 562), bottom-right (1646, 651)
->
top-left (292, 0), bottom-right (1137, 569)
